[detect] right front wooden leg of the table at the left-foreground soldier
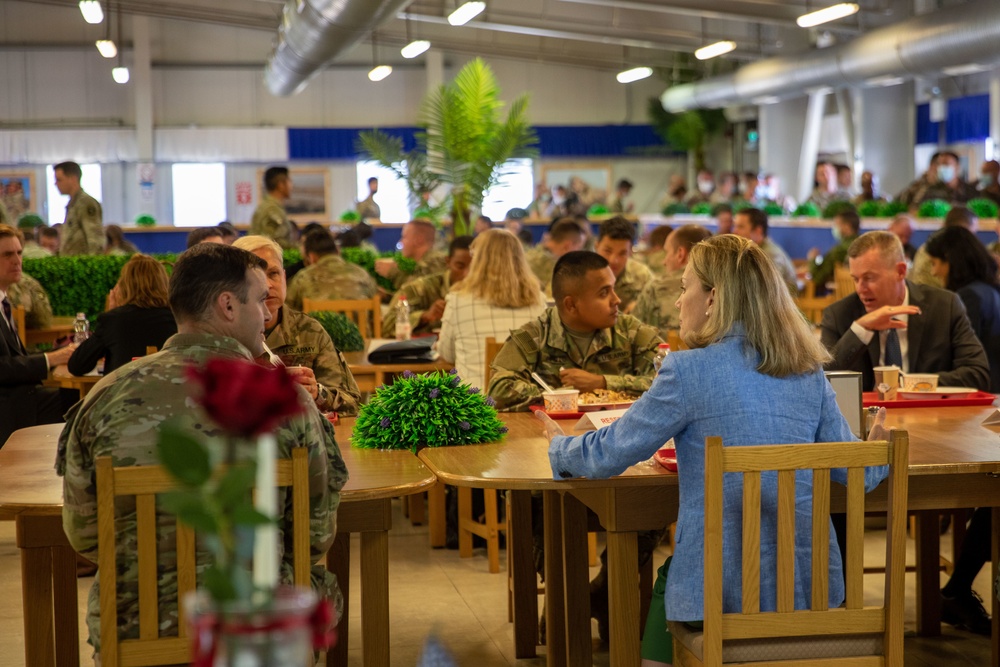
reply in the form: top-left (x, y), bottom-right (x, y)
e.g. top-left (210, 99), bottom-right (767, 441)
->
top-left (361, 530), bottom-right (389, 667)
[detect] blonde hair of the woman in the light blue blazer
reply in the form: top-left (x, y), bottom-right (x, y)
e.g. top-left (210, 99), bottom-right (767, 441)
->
top-left (685, 234), bottom-right (831, 378)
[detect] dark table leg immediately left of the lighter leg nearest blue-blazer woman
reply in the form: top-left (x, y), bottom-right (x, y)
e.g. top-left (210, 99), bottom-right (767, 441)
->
top-left (562, 493), bottom-right (594, 665)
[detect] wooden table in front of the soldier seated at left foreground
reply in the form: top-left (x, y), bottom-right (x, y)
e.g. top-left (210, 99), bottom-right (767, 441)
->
top-left (0, 420), bottom-right (436, 667)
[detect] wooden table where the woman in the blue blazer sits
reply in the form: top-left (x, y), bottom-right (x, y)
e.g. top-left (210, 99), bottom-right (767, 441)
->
top-left (418, 407), bottom-right (1000, 667)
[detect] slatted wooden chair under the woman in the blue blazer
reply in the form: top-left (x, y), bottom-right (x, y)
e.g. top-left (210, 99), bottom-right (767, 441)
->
top-left (669, 431), bottom-right (909, 667)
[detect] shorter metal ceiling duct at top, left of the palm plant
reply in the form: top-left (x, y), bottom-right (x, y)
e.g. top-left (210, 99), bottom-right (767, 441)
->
top-left (264, 0), bottom-right (410, 96)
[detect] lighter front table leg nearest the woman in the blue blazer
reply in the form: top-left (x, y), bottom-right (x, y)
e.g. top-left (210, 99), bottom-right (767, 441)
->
top-left (608, 531), bottom-right (641, 667)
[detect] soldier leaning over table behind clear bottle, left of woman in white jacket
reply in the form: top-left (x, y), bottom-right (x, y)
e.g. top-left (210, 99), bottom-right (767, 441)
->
top-left (382, 236), bottom-right (472, 336)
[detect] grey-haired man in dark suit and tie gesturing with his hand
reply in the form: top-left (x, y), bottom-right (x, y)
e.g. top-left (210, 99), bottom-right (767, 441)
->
top-left (821, 231), bottom-right (990, 391)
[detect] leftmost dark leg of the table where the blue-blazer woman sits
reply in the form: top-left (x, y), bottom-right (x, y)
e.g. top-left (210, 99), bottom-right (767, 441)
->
top-left (507, 491), bottom-right (538, 660)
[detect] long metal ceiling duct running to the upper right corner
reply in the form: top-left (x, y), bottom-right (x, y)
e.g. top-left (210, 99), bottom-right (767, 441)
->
top-left (660, 0), bottom-right (1000, 112)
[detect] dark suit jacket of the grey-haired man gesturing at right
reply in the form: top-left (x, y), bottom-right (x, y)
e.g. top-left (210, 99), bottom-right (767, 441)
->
top-left (820, 281), bottom-right (990, 391)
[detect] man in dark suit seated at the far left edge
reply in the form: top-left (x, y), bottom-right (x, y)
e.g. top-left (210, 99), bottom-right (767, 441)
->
top-left (0, 225), bottom-right (76, 447)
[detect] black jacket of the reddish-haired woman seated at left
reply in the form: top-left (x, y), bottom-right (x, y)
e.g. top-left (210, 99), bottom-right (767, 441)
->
top-left (67, 305), bottom-right (177, 375)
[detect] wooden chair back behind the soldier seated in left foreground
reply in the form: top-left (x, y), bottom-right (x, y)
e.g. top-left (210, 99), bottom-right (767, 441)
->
top-left (97, 447), bottom-right (311, 667)
